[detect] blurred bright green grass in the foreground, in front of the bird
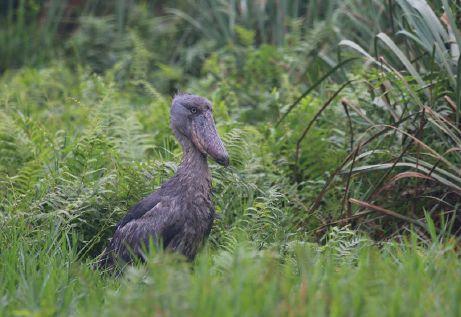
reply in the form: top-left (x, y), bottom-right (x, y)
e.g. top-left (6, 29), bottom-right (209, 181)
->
top-left (0, 223), bottom-right (461, 316)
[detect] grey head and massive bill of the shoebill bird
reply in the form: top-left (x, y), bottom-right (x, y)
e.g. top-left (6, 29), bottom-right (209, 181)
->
top-left (170, 94), bottom-right (229, 166)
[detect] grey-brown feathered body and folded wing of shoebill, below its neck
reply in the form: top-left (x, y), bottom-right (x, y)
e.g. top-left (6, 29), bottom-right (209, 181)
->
top-left (101, 178), bottom-right (214, 266)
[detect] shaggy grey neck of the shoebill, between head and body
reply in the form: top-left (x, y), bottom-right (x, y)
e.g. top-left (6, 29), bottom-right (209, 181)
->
top-left (176, 133), bottom-right (211, 192)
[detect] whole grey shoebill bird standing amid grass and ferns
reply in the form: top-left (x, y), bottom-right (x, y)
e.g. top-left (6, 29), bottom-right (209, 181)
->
top-left (98, 93), bottom-right (229, 268)
